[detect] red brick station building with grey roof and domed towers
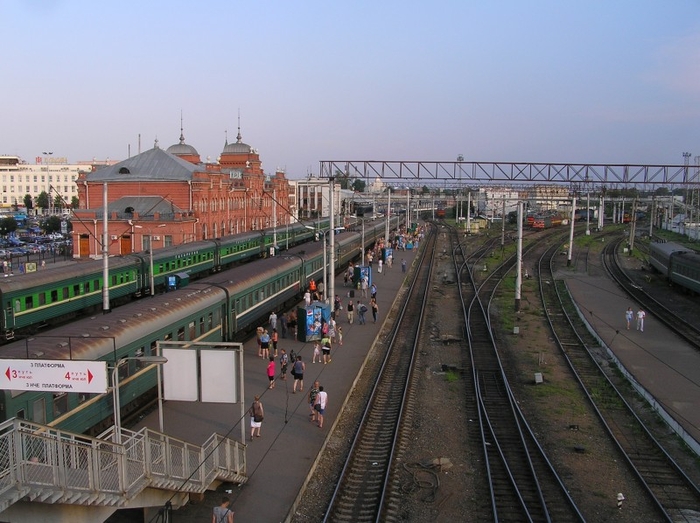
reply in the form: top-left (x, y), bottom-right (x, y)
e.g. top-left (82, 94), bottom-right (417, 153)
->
top-left (72, 129), bottom-right (292, 258)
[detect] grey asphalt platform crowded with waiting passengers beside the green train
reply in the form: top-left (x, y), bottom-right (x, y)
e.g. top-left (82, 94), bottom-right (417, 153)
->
top-left (129, 250), bottom-right (416, 523)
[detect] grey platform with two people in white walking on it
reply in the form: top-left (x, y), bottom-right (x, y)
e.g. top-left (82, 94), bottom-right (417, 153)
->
top-left (560, 273), bottom-right (700, 452)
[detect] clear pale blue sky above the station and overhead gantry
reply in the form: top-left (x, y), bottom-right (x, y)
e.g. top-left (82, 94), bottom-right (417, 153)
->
top-left (0, 0), bottom-right (700, 178)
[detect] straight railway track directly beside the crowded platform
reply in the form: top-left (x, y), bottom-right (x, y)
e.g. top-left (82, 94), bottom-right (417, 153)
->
top-left (324, 223), bottom-right (436, 522)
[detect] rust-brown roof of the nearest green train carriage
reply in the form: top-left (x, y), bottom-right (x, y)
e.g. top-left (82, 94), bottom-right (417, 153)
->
top-left (0, 283), bottom-right (225, 360)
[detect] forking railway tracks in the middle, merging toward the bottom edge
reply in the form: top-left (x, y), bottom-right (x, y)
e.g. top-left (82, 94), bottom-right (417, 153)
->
top-left (454, 226), bottom-right (583, 522)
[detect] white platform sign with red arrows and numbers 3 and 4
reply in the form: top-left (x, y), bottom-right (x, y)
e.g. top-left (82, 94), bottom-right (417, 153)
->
top-left (0, 360), bottom-right (107, 394)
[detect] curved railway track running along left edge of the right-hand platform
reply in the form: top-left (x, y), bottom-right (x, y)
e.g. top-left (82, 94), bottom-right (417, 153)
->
top-left (538, 242), bottom-right (700, 521)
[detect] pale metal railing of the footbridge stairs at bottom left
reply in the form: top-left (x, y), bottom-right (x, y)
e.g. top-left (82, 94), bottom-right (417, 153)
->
top-left (0, 419), bottom-right (247, 512)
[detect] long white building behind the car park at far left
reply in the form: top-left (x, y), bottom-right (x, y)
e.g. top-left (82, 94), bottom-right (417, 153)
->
top-left (0, 156), bottom-right (86, 211)
